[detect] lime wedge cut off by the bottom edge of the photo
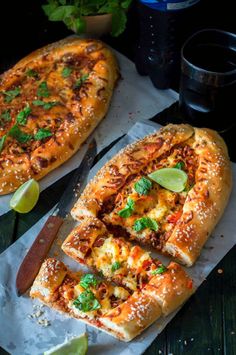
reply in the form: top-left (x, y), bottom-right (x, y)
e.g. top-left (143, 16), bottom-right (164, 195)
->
top-left (44, 333), bottom-right (88, 355)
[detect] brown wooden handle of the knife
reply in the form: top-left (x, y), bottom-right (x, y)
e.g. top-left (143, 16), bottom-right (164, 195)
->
top-left (16, 216), bottom-right (63, 296)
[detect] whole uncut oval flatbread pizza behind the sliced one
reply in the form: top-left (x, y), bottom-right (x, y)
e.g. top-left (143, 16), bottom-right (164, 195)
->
top-left (0, 38), bottom-right (118, 195)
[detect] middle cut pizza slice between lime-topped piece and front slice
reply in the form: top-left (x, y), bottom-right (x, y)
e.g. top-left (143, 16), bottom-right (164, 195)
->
top-left (62, 217), bottom-right (193, 304)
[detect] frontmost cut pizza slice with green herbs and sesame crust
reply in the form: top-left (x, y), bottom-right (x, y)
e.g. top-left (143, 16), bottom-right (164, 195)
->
top-left (30, 258), bottom-right (193, 341)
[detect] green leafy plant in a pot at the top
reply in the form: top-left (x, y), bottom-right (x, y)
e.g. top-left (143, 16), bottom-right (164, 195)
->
top-left (42, 0), bottom-right (132, 37)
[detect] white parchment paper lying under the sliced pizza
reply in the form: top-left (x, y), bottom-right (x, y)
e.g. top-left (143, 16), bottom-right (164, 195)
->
top-left (0, 121), bottom-right (236, 355)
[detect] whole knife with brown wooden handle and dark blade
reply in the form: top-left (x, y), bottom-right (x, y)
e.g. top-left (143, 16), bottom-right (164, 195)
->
top-left (16, 139), bottom-right (97, 296)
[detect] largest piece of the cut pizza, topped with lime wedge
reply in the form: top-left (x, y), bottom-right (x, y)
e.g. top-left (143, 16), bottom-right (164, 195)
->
top-left (72, 124), bottom-right (232, 266)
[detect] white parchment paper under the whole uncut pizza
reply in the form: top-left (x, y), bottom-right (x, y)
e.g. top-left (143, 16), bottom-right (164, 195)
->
top-left (0, 50), bottom-right (178, 215)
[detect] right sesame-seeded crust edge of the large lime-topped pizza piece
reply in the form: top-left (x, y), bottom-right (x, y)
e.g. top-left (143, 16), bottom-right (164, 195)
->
top-left (164, 128), bottom-right (232, 266)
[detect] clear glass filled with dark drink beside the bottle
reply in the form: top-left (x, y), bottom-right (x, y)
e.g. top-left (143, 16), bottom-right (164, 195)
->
top-left (179, 29), bottom-right (236, 132)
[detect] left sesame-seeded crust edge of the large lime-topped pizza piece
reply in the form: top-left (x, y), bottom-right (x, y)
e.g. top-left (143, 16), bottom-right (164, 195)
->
top-left (71, 124), bottom-right (194, 220)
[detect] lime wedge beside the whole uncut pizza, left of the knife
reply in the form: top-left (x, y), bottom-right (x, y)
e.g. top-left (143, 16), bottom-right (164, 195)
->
top-left (10, 179), bottom-right (39, 213)
